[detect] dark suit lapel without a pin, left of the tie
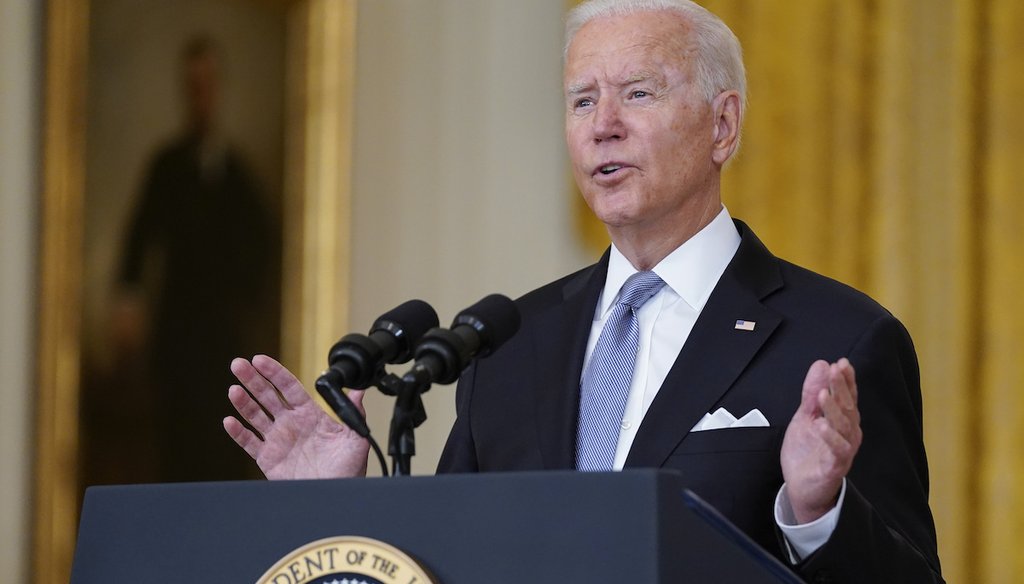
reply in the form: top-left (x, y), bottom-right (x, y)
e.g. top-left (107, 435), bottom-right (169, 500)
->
top-left (534, 252), bottom-right (608, 469)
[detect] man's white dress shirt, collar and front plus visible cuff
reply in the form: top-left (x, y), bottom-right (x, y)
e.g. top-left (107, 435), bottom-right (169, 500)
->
top-left (584, 207), bottom-right (846, 562)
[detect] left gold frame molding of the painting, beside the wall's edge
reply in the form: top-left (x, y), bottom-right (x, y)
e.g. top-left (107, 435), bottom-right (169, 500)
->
top-left (32, 0), bottom-right (89, 582)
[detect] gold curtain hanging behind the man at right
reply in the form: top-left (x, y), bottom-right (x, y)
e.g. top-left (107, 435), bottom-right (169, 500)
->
top-left (569, 0), bottom-right (1024, 583)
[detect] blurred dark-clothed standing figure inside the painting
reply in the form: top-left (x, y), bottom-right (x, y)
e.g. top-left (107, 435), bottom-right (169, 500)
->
top-left (109, 38), bottom-right (281, 482)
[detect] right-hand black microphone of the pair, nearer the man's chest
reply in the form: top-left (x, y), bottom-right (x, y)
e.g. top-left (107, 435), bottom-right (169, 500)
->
top-left (403, 294), bottom-right (519, 391)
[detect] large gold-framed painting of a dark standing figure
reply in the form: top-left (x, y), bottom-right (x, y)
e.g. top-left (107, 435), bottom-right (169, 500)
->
top-left (33, 0), bottom-right (355, 582)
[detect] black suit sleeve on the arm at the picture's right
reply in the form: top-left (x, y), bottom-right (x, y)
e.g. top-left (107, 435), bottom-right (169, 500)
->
top-left (798, 315), bottom-right (943, 583)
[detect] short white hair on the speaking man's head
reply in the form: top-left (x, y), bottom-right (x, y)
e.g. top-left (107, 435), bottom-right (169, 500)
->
top-left (564, 0), bottom-right (746, 111)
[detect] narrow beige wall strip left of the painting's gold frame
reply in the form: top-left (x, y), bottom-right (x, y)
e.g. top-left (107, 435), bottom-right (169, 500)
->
top-left (0, 0), bottom-right (40, 583)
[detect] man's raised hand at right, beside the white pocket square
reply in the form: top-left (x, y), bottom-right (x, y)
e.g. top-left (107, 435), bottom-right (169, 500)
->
top-left (781, 359), bottom-right (863, 524)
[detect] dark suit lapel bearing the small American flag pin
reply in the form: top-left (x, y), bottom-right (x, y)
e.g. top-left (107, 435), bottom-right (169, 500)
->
top-left (626, 221), bottom-right (782, 467)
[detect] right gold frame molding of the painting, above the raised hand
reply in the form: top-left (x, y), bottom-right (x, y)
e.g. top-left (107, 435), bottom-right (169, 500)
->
top-left (282, 0), bottom-right (356, 386)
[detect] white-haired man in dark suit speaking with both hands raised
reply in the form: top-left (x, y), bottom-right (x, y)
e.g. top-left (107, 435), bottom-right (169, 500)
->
top-left (224, 0), bottom-right (942, 582)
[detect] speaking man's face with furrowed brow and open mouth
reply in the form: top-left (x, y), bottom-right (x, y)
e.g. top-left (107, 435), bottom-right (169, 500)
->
top-left (565, 11), bottom-right (719, 237)
